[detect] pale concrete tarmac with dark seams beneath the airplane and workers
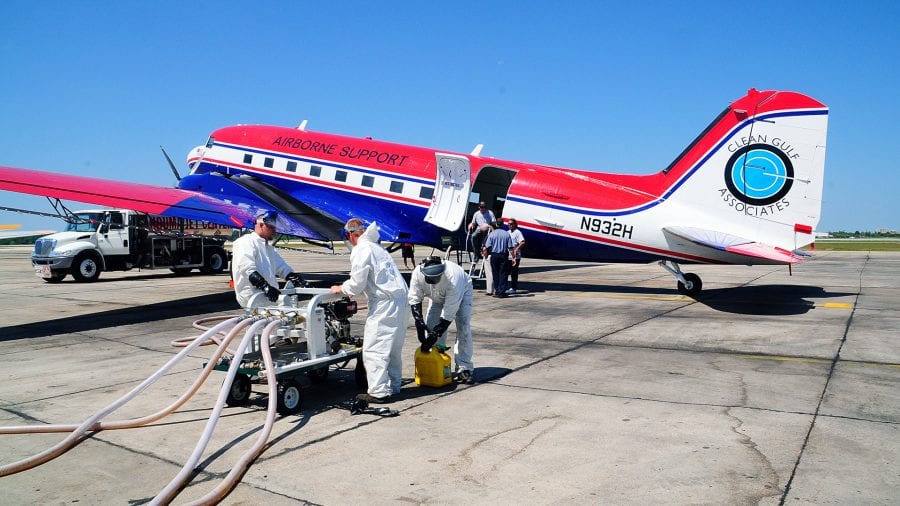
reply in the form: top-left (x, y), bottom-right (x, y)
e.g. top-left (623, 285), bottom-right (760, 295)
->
top-left (0, 247), bottom-right (900, 504)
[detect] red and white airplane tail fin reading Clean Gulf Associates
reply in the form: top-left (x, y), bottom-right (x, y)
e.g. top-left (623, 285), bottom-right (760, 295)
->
top-left (664, 89), bottom-right (828, 252)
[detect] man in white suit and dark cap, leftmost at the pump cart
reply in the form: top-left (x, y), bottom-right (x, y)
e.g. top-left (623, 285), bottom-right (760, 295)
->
top-left (231, 211), bottom-right (306, 307)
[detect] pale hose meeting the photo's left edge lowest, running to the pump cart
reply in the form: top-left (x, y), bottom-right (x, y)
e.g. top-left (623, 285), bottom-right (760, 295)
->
top-left (0, 317), bottom-right (243, 477)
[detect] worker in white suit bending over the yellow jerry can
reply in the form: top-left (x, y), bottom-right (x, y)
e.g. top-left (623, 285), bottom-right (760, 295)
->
top-left (409, 256), bottom-right (475, 384)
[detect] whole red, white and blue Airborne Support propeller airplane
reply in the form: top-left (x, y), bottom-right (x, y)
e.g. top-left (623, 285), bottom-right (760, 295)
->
top-left (0, 88), bottom-right (828, 296)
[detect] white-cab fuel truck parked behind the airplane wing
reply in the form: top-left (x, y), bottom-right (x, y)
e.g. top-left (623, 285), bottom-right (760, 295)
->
top-left (31, 209), bottom-right (231, 283)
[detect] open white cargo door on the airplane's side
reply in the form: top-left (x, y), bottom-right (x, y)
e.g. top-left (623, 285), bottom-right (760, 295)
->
top-left (425, 153), bottom-right (472, 232)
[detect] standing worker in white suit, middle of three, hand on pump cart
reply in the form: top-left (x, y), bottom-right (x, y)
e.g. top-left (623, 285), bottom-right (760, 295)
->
top-left (331, 218), bottom-right (409, 403)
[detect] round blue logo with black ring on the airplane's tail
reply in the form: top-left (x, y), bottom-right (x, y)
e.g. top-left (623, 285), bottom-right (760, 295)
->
top-left (725, 144), bottom-right (794, 206)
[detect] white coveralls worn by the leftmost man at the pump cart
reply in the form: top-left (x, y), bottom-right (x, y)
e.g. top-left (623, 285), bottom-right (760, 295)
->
top-left (231, 232), bottom-right (294, 307)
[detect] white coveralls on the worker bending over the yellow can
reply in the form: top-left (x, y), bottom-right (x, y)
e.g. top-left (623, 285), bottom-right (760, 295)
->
top-left (409, 260), bottom-right (475, 372)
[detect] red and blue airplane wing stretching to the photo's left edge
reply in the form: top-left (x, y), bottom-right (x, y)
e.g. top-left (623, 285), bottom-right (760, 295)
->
top-left (0, 166), bottom-right (340, 240)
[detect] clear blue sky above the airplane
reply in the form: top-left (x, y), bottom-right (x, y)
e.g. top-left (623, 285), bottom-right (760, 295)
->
top-left (0, 1), bottom-right (900, 231)
